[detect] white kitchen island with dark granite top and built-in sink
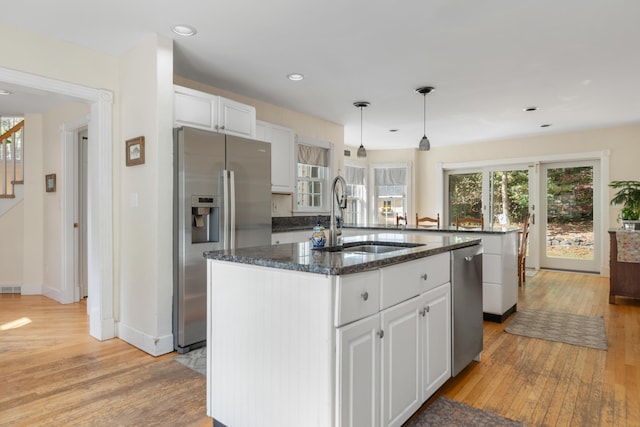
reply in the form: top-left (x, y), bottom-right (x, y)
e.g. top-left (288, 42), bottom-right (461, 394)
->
top-left (205, 232), bottom-right (482, 427)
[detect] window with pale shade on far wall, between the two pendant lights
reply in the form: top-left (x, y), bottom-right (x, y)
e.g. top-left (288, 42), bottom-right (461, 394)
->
top-left (372, 164), bottom-right (410, 225)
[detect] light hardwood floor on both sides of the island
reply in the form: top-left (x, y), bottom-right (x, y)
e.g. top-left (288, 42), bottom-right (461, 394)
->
top-left (0, 271), bottom-right (640, 427)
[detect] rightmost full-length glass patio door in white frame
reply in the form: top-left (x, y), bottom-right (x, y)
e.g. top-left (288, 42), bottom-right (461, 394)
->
top-left (538, 160), bottom-right (601, 273)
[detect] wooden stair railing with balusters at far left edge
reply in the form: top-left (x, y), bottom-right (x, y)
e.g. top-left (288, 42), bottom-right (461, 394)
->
top-left (0, 120), bottom-right (24, 198)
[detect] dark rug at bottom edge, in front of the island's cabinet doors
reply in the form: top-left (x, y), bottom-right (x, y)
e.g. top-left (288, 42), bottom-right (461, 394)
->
top-left (406, 396), bottom-right (524, 427)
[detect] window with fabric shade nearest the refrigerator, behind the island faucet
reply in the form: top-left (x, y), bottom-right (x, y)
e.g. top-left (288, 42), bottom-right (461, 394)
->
top-left (296, 141), bottom-right (330, 212)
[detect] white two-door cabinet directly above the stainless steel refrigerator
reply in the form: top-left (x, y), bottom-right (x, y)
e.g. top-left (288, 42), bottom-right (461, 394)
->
top-left (173, 85), bottom-right (256, 138)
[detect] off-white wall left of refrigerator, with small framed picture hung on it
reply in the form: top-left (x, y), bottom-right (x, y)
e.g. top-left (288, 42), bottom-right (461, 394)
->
top-left (114, 37), bottom-right (173, 355)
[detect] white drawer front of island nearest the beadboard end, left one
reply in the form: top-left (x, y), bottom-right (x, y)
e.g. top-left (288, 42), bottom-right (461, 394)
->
top-left (334, 270), bottom-right (380, 326)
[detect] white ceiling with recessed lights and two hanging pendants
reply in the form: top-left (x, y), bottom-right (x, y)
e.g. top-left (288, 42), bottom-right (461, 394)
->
top-left (0, 0), bottom-right (640, 149)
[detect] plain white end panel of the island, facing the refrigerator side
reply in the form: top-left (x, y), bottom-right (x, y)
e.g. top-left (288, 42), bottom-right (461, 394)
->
top-left (207, 261), bottom-right (335, 427)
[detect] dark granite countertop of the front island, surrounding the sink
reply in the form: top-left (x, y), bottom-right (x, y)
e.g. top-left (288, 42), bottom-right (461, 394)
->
top-left (204, 232), bottom-right (481, 275)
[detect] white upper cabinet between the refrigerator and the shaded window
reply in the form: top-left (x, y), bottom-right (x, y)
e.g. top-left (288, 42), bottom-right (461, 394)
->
top-left (256, 121), bottom-right (297, 193)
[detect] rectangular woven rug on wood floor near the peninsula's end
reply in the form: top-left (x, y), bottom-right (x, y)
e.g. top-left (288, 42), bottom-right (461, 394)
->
top-left (505, 310), bottom-right (607, 350)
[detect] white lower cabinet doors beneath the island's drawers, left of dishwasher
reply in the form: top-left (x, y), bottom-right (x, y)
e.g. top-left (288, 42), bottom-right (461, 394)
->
top-left (336, 282), bottom-right (451, 427)
